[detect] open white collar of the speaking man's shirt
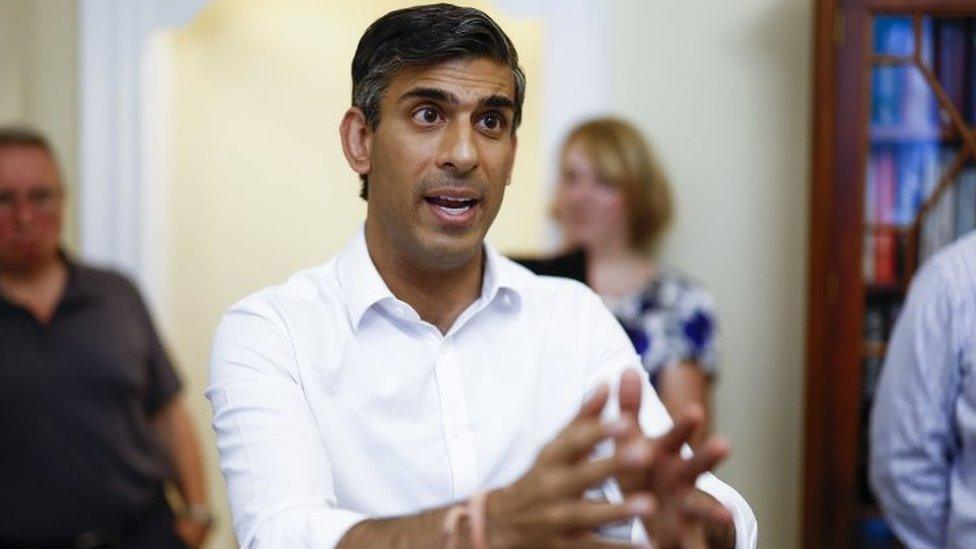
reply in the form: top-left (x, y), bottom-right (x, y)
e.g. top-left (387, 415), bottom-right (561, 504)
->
top-left (336, 226), bottom-right (523, 328)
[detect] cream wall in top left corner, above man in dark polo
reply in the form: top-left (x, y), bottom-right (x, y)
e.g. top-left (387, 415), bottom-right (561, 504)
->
top-left (0, 0), bottom-right (78, 249)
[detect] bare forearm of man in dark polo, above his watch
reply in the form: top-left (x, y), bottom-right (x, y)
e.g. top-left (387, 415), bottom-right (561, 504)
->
top-left (157, 397), bottom-right (207, 505)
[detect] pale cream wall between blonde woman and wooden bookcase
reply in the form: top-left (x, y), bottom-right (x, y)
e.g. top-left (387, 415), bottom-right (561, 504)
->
top-left (613, 0), bottom-right (812, 548)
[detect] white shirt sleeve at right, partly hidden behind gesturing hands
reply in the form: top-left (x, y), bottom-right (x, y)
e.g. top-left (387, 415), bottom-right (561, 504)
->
top-left (580, 284), bottom-right (758, 549)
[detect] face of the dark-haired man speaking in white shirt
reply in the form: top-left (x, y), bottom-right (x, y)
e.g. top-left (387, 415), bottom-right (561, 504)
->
top-left (367, 58), bottom-right (516, 268)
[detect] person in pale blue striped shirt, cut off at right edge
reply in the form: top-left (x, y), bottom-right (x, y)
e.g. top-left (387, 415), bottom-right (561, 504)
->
top-left (870, 233), bottom-right (976, 549)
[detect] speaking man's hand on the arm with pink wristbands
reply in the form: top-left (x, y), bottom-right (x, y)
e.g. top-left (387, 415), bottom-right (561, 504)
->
top-left (486, 386), bottom-right (655, 549)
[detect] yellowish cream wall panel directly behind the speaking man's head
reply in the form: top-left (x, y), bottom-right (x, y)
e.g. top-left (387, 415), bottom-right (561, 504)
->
top-left (156, 0), bottom-right (545, 547)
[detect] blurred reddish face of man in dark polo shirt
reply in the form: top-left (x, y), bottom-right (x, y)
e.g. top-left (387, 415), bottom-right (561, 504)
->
top-left (0, 146), bottom-right (63, 270)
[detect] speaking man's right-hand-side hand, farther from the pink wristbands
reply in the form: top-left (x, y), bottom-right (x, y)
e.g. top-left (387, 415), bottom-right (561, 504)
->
top-left (615, 370), bottom-right (734, 549)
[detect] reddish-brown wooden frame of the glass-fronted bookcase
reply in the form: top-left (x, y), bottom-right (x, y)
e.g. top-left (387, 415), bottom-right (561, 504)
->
top-left (802, 0), bottom-right (976, 548)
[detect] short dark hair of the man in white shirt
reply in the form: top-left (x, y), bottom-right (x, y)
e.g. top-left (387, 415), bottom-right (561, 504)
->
top-left (352, 4), bottom-right (525, 200)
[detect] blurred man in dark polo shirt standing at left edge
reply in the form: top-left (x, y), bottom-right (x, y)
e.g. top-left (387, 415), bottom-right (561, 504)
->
top-left (0, 128), bottom-right (209, 549)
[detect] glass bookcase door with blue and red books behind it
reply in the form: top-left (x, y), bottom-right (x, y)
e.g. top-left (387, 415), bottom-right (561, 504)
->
top-left (855, 13), bottom-right (976, 547)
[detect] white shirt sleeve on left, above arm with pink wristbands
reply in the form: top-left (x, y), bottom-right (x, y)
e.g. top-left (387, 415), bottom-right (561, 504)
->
top-left (207, 299), bottom-right (366, 549)
